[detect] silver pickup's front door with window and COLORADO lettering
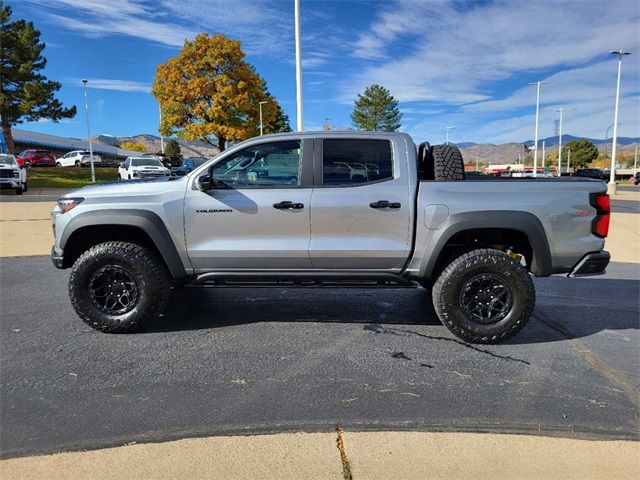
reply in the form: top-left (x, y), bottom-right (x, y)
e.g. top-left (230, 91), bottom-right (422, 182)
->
top-left (184, 139), bottom-right (313, 273)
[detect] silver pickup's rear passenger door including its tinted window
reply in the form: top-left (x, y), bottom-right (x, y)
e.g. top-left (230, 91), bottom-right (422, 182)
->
top-left (309, 136), bottom-right (414, 271)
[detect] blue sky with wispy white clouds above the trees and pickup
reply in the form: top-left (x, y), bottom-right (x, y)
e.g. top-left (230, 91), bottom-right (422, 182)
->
top-left (7, 0), bottom-right (640, 143)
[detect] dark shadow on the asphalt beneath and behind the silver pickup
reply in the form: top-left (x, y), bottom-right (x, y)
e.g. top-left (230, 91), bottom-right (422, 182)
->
top-left (143, 278), bottom-right (640, 344)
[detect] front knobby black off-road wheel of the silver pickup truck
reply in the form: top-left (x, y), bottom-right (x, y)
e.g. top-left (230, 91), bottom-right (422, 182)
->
top-left (69, 241), bottom-right (170, 333)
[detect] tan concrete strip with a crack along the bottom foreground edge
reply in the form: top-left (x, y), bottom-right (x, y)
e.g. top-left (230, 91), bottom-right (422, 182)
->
top-left (0, 432), bottom-right (640, 480)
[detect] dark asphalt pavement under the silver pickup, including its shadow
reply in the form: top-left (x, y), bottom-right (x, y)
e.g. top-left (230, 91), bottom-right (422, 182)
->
top-left (0, 257), bottom-right (640, 457)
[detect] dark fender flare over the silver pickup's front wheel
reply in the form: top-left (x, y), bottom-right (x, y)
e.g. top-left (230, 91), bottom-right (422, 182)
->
top-left (60, 209), bottom-right (187, 278)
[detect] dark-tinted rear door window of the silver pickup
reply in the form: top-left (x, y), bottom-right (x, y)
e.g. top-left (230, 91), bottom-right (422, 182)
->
top-left (322, 138), bottom-right (393, 187)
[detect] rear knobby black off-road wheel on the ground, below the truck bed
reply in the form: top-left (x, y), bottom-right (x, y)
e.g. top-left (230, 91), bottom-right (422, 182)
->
top-left (432, 249), bottom-right (535, 343)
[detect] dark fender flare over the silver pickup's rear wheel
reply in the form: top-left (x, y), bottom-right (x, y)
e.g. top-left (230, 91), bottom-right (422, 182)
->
top-left (419, 210), bottom-right (553, 278)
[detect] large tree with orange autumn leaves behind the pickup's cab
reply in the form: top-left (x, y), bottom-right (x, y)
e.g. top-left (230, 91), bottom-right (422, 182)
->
top-left (152, 33), bottom-right (278, 150)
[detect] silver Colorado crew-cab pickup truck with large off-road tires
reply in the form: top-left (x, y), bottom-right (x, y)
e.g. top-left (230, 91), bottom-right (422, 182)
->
top-left (51, 132), bottom-right (610, 343)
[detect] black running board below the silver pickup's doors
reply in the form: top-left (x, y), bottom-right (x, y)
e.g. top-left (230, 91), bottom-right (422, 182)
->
top-left (194, 271), bottom-right (415, 287)
